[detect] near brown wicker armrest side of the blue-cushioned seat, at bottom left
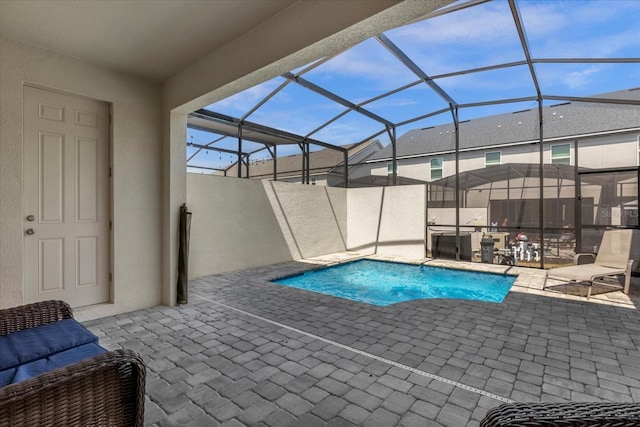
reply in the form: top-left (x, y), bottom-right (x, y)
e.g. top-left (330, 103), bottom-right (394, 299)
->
top-left (0, 350), bottom-right (146, 427)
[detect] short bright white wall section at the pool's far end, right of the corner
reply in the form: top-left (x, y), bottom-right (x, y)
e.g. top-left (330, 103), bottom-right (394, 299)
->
top-left (347, 185), bottom-right (426, 258)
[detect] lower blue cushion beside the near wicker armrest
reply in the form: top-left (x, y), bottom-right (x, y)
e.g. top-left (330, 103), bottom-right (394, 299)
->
top-left (0, 343), bottom-right (106, 387)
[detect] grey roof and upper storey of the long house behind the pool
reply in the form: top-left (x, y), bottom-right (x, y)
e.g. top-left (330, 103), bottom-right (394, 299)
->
top-left (350, 88), bottom-right (640, 181)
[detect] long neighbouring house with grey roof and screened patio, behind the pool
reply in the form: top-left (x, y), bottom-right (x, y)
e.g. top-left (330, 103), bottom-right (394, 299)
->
top-left (350, 88), bottom-right (640, 247)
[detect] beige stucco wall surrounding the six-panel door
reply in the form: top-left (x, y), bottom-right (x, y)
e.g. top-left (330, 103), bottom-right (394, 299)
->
top-left (0, 38), bottom-right (162, 314)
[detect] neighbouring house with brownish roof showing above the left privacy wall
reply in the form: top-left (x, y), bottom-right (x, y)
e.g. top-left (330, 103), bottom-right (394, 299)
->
top-left (225, 139), bottom-right (383, 187)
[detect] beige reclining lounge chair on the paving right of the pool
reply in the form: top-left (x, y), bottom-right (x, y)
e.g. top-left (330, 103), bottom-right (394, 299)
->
top-left (543, 230), bottom-right (634, 299)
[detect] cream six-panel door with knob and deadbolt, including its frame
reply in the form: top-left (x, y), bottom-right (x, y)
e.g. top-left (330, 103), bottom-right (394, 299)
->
top-left (23, 86), bottom-right (109, 307)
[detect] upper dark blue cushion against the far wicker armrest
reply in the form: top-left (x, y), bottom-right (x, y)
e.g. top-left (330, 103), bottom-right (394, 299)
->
top-left (0, 319), bottom-right (98, 371)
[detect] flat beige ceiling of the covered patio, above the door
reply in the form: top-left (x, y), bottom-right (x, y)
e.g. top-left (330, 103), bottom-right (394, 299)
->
top-left (0, 0), bottom-right (295, 80)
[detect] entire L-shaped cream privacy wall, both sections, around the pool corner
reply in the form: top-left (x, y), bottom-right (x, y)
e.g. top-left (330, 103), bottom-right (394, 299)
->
top-left (187, 174), bottom-right (425, 278)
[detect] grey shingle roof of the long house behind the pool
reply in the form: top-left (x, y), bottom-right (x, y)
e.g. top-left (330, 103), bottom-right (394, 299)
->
top-left (371, 88), bottom-right (640, 161)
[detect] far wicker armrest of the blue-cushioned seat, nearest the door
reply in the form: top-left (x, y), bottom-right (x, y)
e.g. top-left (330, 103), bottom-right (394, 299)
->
top-left (0, 301), bottom-right (73, 335)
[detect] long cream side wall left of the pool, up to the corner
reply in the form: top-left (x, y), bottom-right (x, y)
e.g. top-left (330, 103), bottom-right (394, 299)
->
top-left (187, 174), bottom-right (347, 278)
